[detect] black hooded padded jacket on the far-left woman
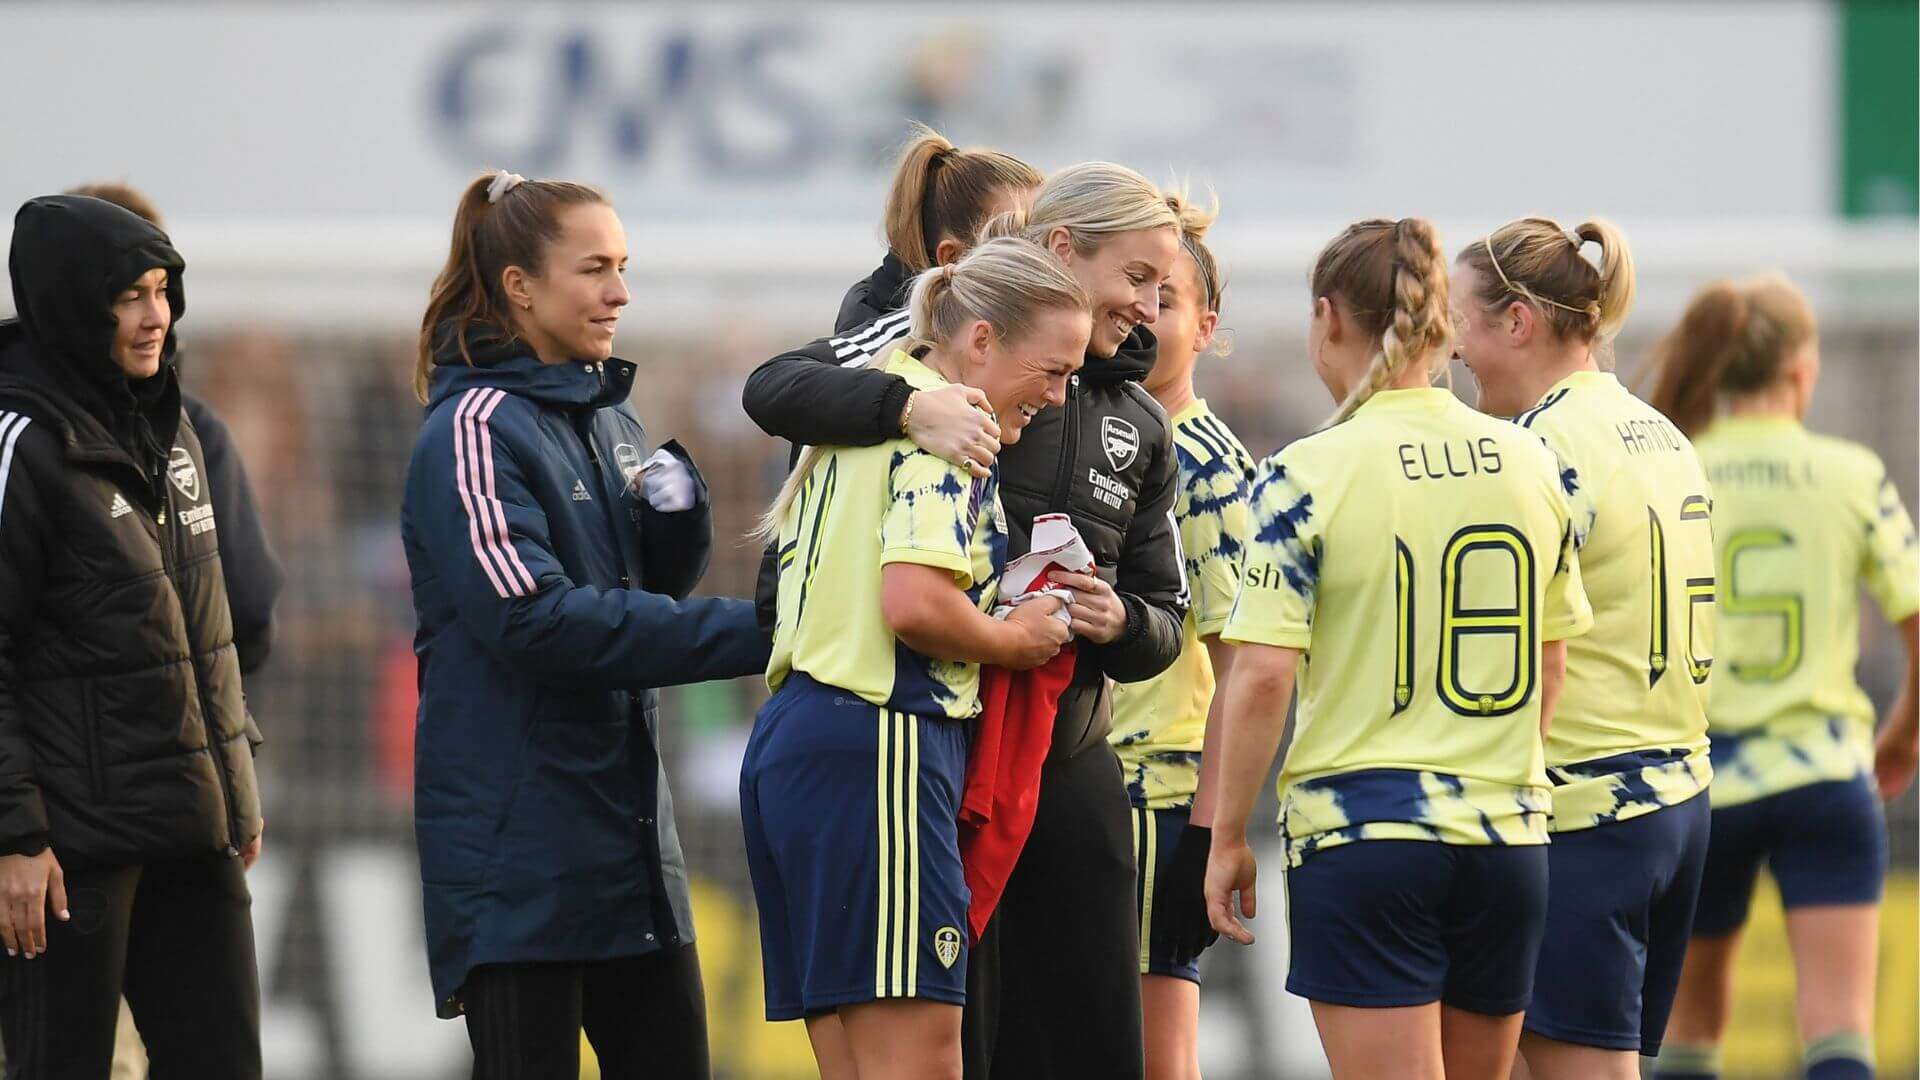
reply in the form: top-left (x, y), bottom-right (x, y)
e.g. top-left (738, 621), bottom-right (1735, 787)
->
top-left (0, 196), bottom-right (261, 867)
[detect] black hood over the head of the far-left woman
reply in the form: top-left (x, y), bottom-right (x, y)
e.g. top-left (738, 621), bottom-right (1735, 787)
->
top-left (8, 194), bottom-right (186, 390)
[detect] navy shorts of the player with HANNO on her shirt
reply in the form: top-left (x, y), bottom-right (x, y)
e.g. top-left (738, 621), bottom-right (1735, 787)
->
top-left (1526, 792), bottom-right (1711, 1057)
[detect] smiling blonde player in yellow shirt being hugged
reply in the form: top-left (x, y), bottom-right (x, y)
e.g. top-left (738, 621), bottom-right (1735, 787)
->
top-left (739, 238), bottom-right (1092, 1080)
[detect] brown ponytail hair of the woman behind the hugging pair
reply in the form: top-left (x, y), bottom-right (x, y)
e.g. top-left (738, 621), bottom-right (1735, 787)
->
top-left (881, 123), bottom-right (1043, 273)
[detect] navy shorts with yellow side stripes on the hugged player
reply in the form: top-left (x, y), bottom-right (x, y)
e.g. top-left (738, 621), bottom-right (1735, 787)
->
top-left (739, 673), bottom-right (968, 1020)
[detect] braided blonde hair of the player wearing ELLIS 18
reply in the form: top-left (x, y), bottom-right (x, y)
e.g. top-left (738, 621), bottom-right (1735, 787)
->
top-left (1313, 217), bottom-right (1453, 427)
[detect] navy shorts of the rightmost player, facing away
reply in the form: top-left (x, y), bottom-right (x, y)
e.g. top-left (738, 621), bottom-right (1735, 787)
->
top-left (1693, 774), bottom-right (1887, 938)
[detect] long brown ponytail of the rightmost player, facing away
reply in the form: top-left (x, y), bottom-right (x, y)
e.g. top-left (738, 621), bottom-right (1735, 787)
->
top-left (1647, 275), bottom-right (1816, 434)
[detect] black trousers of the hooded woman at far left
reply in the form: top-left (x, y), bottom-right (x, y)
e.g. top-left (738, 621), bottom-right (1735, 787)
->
top-left (0, 855), bottom-right (261, 1080)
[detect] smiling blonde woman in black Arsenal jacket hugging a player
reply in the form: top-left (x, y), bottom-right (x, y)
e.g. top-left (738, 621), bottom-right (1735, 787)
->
top-left (745, 161), bottom-right (1187, 1080)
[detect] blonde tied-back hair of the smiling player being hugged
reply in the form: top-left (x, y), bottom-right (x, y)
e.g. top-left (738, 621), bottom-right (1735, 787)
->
top-left (753, 236), bottom-right (1091, 542)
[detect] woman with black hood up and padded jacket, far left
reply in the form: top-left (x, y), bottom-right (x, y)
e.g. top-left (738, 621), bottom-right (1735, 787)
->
top-left (0, 196), bottom-right (261, 1080)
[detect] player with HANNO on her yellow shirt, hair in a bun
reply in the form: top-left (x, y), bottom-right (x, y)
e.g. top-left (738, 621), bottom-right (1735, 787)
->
top-left (1453, 217), bottom-right (1713, 1080)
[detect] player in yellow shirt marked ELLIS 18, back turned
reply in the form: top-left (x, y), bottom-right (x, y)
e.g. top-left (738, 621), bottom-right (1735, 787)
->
top-left (1200, 219), bottom-right (1592, 1080)
